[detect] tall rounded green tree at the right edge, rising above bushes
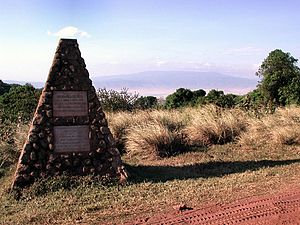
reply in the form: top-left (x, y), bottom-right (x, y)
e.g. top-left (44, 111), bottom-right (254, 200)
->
top-left (256, 49), bottom-right (300, 106)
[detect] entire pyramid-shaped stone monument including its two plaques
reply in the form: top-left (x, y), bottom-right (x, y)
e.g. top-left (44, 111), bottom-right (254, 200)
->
top-left (13, 39), bottom-right (126, 187)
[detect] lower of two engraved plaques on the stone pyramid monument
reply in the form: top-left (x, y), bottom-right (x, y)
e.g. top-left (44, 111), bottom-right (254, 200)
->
top-left (53, 125), bottom-right (90, 153)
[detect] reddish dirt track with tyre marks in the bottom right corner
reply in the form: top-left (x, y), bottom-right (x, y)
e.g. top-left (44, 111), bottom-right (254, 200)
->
top-left (128, 190), bottom-right (300, 225)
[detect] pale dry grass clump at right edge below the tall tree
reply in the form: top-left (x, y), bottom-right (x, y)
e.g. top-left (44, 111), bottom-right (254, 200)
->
top-left (239, 106), bottom-right (300, 147)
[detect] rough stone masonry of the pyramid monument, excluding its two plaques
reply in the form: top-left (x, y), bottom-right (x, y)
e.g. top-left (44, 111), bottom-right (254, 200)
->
top-left (13, 39), bottom-right (126, 187)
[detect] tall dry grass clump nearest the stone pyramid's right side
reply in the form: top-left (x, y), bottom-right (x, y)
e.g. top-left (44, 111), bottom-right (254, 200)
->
top-left (108, 110), bottom-right (185, 157)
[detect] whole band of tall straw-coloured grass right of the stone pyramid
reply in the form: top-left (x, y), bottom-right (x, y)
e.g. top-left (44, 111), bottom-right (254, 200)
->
top-left (108, 105), bottom-right (300, 158)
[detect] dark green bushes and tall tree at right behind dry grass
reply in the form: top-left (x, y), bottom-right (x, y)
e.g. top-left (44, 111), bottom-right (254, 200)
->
top-left (165, 49), bottom-right (300, 112)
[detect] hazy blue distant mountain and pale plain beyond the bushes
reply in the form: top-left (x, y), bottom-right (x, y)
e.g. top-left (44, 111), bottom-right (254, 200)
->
top-left (5, 71), bottom-right (257, 96)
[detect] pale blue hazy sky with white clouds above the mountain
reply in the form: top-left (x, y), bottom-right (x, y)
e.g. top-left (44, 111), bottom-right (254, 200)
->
top-left (0, 0), bottom-right (300, 81)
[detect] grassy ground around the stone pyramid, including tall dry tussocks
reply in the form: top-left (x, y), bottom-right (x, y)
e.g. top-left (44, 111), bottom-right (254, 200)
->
top-left (0, 106), bottom-right (300, 224)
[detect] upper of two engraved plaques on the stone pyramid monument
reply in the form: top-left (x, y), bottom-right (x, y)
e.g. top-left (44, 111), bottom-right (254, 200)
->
top-left (53, 91), bottom-right (88, 117)
